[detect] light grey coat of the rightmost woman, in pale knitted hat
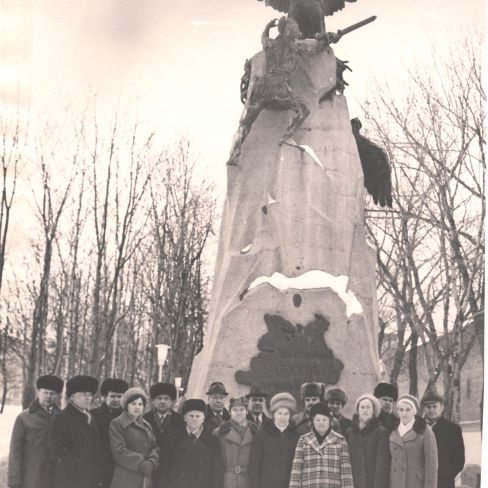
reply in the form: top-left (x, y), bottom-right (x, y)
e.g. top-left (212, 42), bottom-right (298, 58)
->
top-left (390, 417), bottom-right (437, 488)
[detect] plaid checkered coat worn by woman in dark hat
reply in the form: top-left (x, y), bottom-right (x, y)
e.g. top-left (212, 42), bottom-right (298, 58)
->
top-left (289, 430), bottom-right (354, 488)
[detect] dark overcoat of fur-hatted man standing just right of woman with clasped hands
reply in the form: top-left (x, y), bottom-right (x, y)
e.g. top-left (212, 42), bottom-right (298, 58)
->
top-left (144, 410), bottom-right (186, 488)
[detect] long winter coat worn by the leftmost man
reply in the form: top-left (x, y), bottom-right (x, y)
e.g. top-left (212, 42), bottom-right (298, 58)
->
top-left (7, 400), bottom-right (59, 488)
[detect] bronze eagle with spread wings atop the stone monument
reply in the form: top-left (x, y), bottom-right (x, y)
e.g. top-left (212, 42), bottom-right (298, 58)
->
top-left (258, 0), bottom-right (356, 39)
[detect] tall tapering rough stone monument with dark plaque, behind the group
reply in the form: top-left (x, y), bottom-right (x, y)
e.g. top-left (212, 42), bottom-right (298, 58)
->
top-left (188, 0), bottom-right (390, 416)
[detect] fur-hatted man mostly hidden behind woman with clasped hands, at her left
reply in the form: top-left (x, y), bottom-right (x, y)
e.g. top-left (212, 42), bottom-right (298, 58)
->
top-left (90, 378), bottom-right (129, 487)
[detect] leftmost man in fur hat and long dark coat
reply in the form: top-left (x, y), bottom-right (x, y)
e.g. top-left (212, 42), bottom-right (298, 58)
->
top-left (7, 375), bottom-right (63, 488)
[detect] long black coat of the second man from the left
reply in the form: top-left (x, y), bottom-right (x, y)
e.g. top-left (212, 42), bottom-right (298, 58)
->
top-left (48, 403), bottom-right (103, 488)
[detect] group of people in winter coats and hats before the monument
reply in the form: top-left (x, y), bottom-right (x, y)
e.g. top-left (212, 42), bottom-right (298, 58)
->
top-left (7, 375), bottom-right (464, 488)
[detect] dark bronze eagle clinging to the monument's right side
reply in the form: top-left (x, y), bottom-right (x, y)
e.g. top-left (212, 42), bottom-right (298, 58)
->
top-left (351, 118), bottom-right (393, 208)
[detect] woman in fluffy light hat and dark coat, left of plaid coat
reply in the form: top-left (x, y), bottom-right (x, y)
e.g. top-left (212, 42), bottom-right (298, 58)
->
top-left (251, 392), bottom-right (298, 488)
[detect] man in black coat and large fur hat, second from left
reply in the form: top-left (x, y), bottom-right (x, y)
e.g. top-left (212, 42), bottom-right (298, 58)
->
top-left (48, 376), bottom-right (103, 488)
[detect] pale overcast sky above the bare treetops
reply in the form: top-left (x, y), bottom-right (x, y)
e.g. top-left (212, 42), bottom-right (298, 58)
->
top-left (0, 0), bottom-right (485, 188)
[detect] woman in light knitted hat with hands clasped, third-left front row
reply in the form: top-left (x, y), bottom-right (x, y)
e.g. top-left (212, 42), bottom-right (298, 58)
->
top-left (109, 388), bottom-right (159, 488)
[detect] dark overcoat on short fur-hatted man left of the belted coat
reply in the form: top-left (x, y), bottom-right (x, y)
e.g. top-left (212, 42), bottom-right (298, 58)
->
top-left (169, 425), bottom-right (223, 488)
